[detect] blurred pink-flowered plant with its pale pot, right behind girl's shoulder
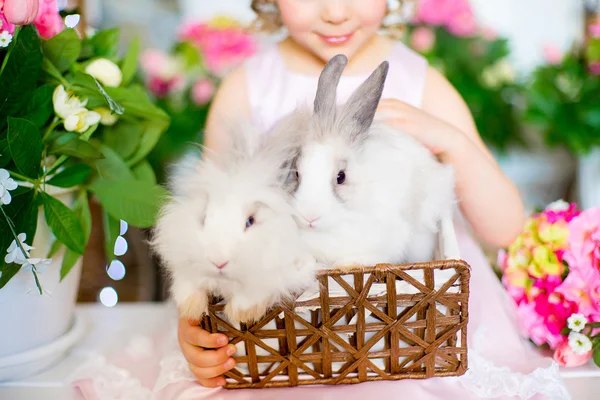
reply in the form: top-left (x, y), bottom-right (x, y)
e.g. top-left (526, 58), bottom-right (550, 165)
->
top-left (406, 0), bottom-right (574, 214)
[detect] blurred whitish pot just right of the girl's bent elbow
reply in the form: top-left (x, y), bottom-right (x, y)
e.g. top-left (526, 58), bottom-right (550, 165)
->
top-left (493, 146), bottom-right (576, 213)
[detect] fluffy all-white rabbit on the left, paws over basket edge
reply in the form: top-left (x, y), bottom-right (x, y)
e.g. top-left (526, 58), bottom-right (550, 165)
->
top-left (151, 125), bottom-right (317, 323)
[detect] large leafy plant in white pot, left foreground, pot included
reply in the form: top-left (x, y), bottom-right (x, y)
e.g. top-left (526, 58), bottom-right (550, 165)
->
top-left (0, 2), bottom-right (169, 380)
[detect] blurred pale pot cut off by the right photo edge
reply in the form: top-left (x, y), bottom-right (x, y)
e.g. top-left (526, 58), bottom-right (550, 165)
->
top-left (577, 148), bottom-right (600, 210)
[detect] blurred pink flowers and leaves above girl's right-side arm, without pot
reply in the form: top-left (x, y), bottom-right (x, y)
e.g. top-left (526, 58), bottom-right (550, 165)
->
top-left (406, 0), bottom-right (525, 151)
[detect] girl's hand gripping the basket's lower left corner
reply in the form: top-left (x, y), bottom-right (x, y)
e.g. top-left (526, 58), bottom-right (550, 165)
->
top-left (177, 318), bottom-right (236, 388)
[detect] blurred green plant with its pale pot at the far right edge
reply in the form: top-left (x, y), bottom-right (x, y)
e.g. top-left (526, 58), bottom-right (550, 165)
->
top-left (526, 10), bottom-right (600, 209)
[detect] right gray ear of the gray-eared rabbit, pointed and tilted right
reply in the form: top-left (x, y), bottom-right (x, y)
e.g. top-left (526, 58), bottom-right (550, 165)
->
top-left (340, 61), bottom-right (389, 141)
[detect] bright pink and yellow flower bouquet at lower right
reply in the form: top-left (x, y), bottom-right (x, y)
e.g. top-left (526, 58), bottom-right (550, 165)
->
top-left (498, 201), bottom-right (600, 367)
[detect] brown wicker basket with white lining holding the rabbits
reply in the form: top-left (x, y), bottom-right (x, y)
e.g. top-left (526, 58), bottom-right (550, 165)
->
top-left (202, 217), bottom-right (470, 389)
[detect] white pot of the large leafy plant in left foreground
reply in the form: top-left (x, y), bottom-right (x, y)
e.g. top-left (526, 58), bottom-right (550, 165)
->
top-left (0, 190), bottom-right (82, 381)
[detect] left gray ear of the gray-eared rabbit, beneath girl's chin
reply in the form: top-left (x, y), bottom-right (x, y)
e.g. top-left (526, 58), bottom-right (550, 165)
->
top-left (314, 54), bottom-right (348, 127)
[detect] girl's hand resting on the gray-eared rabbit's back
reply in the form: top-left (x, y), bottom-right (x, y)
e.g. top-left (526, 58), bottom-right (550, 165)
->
top-left (376, 98), bottom-right (466, 160)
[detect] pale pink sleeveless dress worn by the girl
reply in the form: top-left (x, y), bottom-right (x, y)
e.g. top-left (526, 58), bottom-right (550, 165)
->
top-left (73, 43), bottom-right (571, 400)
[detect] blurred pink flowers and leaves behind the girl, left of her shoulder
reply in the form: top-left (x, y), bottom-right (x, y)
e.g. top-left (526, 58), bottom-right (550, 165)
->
top-left (141, 17), bottom-right (257, 181)
